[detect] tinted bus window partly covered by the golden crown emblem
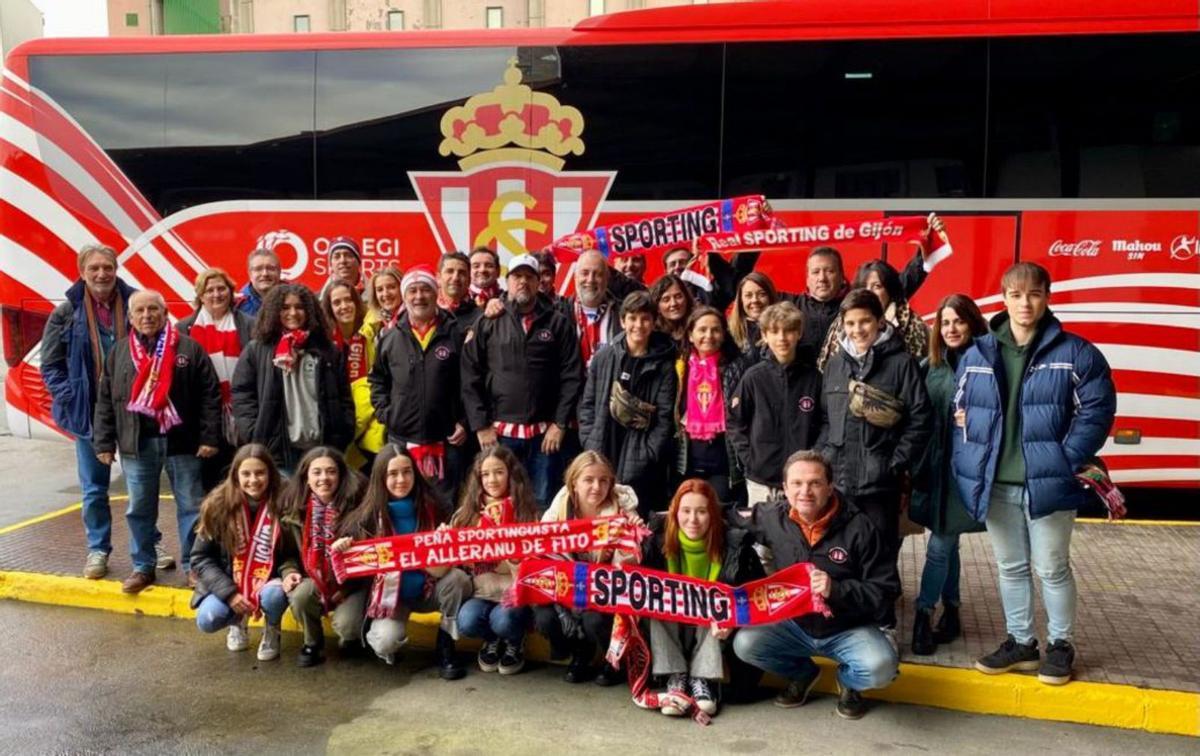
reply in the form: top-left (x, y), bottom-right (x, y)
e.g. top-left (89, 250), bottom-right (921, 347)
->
top-left (317, 46), bottom-right (720, 199)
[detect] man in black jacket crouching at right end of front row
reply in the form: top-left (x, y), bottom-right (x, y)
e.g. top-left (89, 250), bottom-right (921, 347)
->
top-left (733, 451), bottom-right (900, 719)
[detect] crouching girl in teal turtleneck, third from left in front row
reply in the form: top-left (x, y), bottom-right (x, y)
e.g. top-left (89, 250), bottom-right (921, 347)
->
top-left (332, 444), bottom-right (472, 680)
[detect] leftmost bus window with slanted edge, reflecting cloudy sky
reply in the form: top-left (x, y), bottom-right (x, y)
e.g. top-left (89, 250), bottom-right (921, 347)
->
top-left (30, 53), bottom-right (313, 216)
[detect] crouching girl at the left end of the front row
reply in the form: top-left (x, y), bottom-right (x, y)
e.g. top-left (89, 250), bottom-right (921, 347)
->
top-left (191, 444), bottom-right (300, 661)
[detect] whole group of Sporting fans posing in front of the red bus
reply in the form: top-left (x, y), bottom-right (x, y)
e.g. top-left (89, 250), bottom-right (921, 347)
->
top-left (41, 231), bottom-right (1115, 718)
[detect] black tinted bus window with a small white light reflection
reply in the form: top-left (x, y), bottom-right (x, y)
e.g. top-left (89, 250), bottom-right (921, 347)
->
top-left (721, 40), bottom-right (986, 199)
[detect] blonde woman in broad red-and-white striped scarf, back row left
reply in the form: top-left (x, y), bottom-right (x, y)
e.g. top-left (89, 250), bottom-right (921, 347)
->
top-left (178, 268), bottom-right (254, 491)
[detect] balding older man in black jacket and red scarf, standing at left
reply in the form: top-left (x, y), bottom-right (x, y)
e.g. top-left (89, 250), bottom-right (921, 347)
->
top-left (92, 292), bottom-right (221, 593)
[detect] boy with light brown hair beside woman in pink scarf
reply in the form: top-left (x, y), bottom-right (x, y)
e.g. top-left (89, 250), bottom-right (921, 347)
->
top-left (728, 302), bottom-right (822, 506)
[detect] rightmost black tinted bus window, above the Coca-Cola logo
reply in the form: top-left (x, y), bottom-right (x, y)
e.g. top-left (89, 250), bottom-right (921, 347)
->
top-left (988, 34), bottom-right (1200, 197)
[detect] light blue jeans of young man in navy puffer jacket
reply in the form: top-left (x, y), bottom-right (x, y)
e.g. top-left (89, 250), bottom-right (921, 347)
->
top-left (988, 484), bottom-right (1076, 643)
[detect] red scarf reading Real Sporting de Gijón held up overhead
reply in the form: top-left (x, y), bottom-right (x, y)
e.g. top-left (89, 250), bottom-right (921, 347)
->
top-left (692, 215), bottom-right (954, 272)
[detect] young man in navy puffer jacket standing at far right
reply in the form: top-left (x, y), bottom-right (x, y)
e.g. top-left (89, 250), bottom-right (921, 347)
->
top-left (953, 263), bottom-right (1116, 685)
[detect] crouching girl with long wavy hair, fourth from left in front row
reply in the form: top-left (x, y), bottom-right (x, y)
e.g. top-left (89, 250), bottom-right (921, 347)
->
top-left (450, 445), bottom-right (538, 674)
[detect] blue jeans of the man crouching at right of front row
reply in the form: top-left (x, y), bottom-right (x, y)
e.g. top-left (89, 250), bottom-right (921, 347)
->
top-left (733, 620), bottom-right (900, 690)
